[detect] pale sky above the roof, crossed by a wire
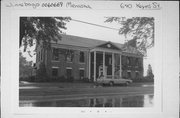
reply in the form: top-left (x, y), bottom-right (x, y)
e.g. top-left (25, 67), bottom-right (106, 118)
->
top-left (65, 16), bottom-right (125, 43)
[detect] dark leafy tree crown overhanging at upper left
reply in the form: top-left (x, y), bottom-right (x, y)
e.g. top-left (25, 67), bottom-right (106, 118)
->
top-left (19, 17), bottom-right (71, 51)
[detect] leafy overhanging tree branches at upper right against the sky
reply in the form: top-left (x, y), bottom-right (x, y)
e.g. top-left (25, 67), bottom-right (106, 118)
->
top-left (105, 17), bottom-right (154, 55)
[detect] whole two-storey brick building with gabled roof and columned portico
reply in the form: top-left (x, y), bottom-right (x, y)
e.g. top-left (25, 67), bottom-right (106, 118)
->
top-left (36, 35), bottom-right (143, 81)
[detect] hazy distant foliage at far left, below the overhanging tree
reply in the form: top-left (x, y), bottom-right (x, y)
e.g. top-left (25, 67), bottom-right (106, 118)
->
top-left (19, 52), bottom-right (33, 79)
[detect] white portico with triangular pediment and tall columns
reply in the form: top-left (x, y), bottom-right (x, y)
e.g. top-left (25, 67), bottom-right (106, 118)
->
top-left (89, 42), bottom-right (122, 81)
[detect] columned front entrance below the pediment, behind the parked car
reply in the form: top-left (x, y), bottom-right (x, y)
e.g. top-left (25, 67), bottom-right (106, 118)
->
top-left (90, 51), bottom-right (121, 81)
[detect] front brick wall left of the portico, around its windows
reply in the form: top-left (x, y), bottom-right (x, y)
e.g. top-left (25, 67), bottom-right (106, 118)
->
top-left (45, 46), bottom-right (88, 80)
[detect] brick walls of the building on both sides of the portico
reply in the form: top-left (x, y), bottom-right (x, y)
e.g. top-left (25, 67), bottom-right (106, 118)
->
top-left (37, 44), bottom-right (143, 80)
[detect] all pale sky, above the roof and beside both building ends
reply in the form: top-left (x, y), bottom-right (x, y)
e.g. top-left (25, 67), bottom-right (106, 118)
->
top-left (20, 14), bottom-right (154, 74)
